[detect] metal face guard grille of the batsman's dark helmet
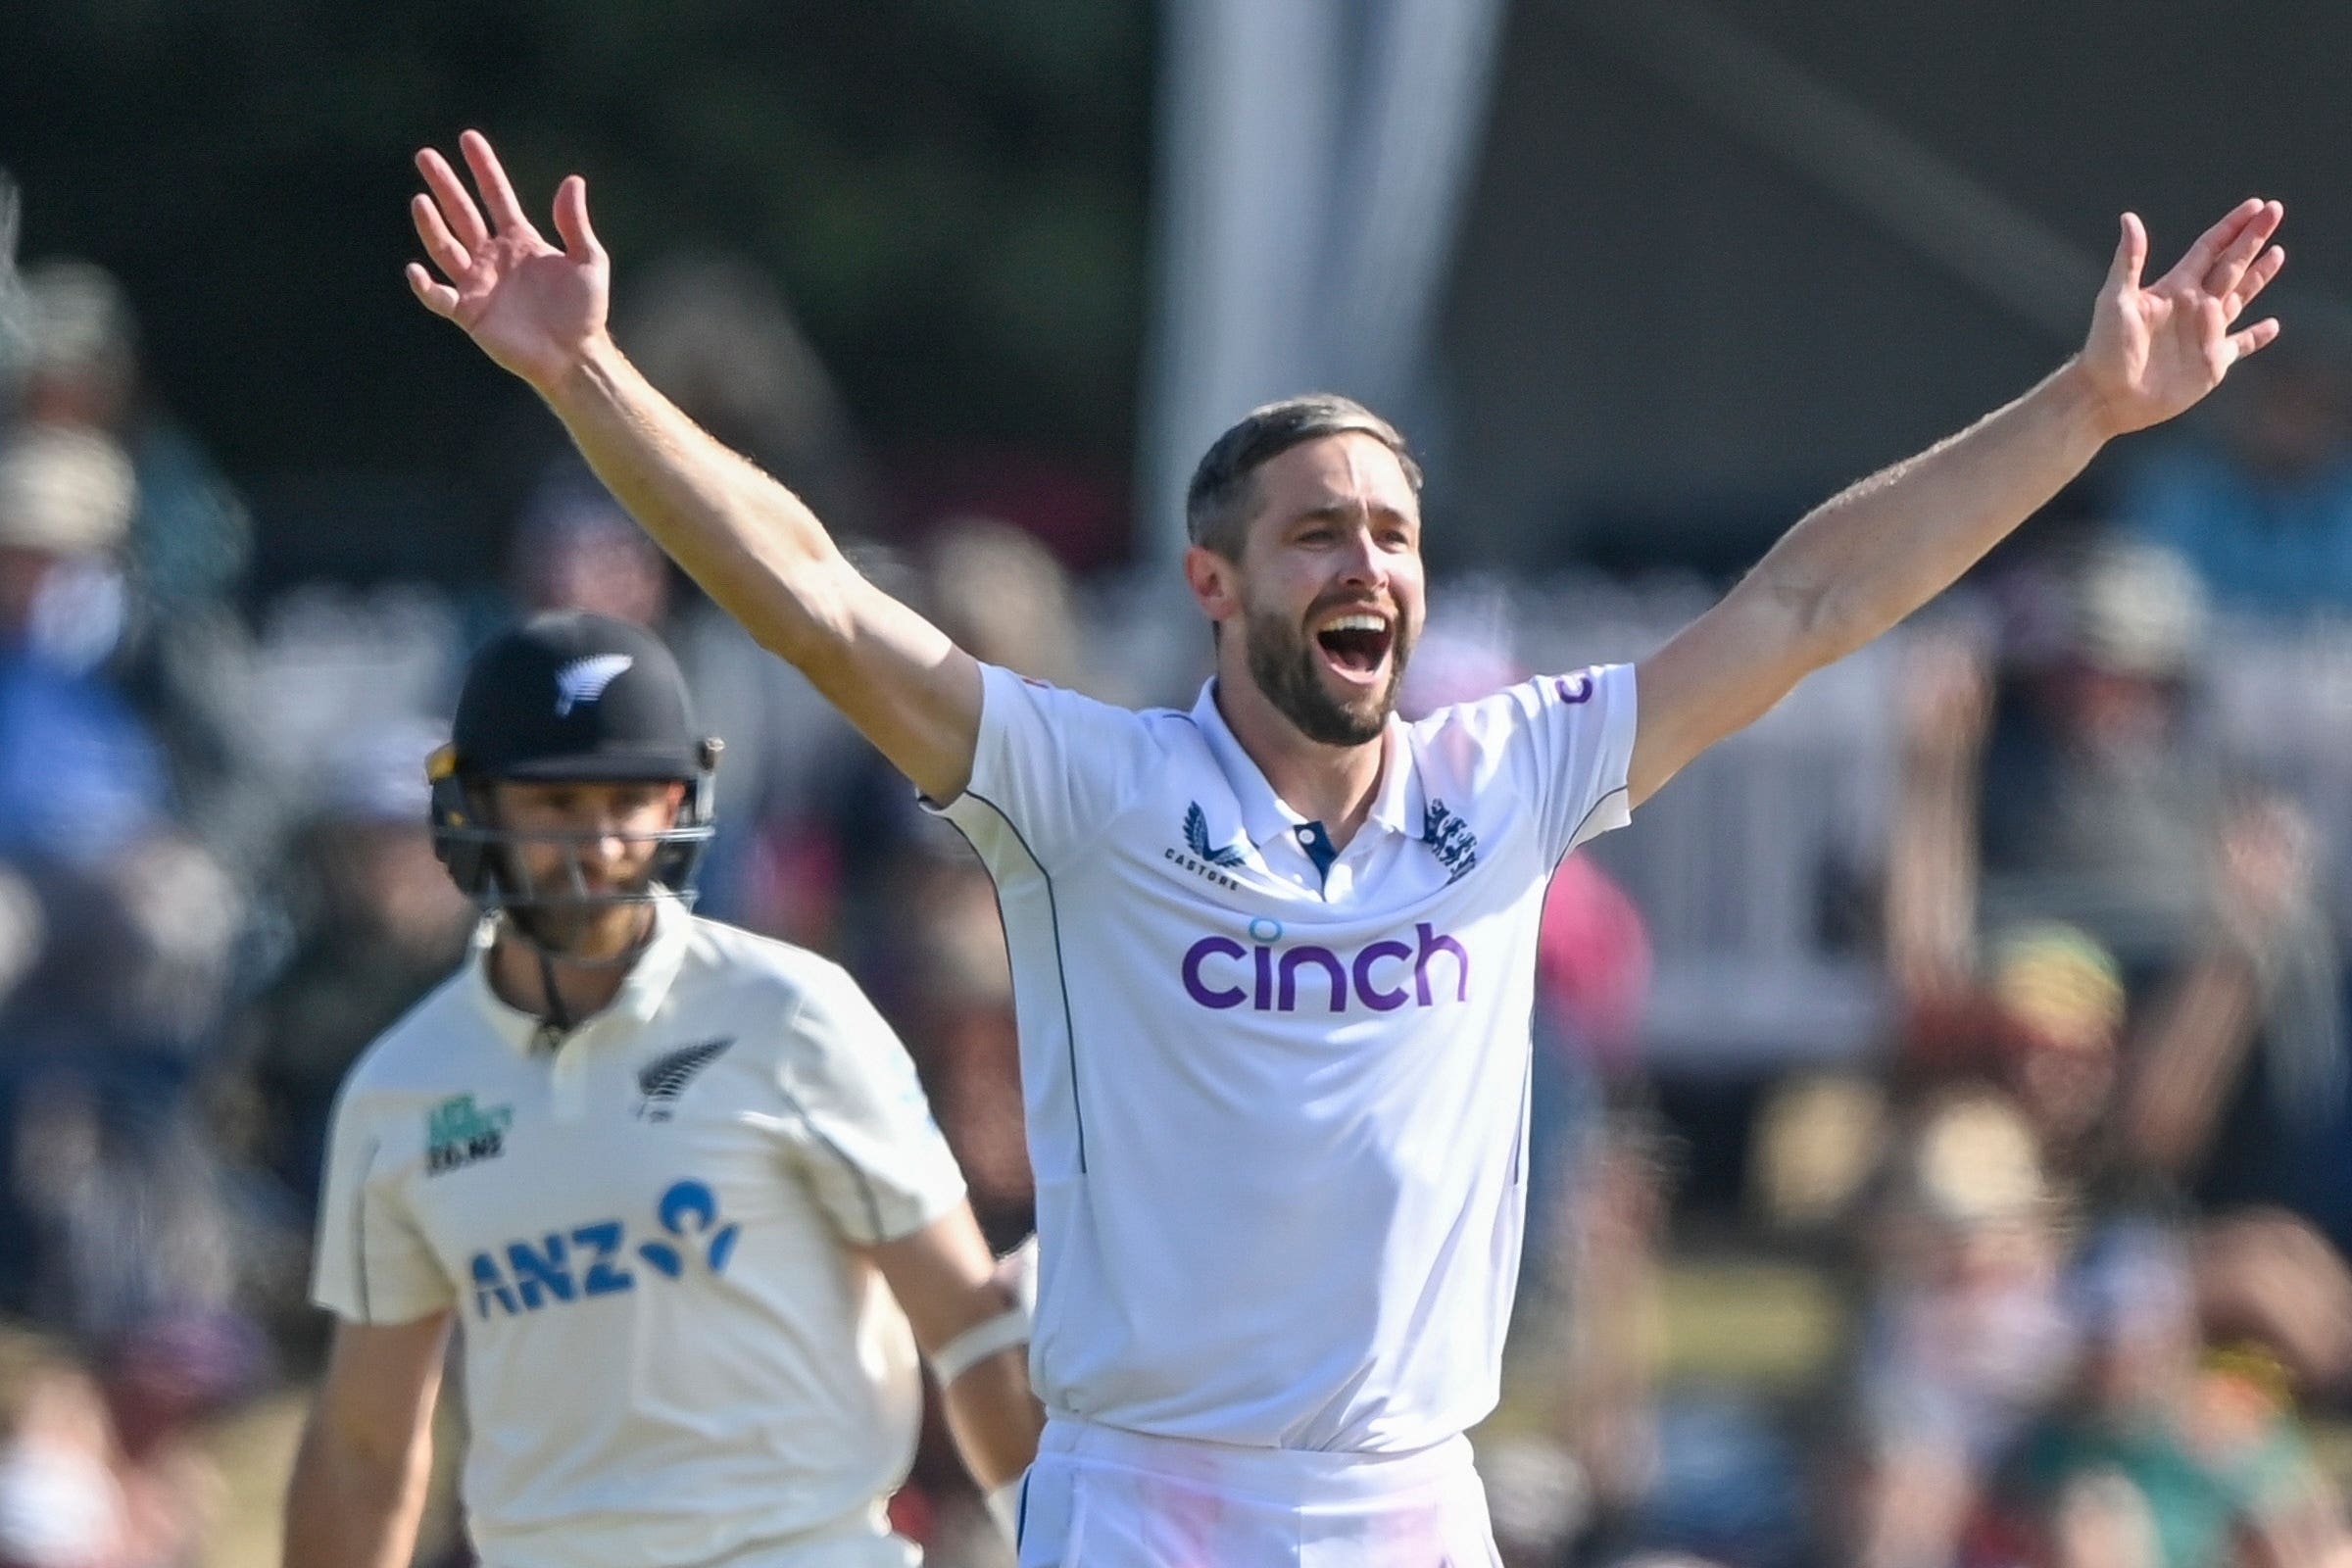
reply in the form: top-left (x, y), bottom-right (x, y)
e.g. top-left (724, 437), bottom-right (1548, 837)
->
top-left (428, 741), bottom-right (719, 912)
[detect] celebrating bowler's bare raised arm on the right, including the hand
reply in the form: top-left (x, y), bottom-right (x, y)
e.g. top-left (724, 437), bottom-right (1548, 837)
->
top-left (1630, 200), bottom-right (2286, 804)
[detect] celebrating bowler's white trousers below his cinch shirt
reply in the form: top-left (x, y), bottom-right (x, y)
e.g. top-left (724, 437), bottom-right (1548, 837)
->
top-left (1021, 1415), bottom-right (1500, 1568)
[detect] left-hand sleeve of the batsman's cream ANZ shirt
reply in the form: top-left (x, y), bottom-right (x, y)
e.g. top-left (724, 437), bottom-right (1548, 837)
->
top-left (311, 1086), bottom-right (457, 1324)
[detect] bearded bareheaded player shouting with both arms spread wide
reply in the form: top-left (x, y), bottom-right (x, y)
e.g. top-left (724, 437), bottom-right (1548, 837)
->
top-left (407, 131), bottom-right (2283, 1568)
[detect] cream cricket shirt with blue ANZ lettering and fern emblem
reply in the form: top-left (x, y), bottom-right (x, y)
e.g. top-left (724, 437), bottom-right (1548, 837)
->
top-left (313, 903), bottom-right (964, 1568)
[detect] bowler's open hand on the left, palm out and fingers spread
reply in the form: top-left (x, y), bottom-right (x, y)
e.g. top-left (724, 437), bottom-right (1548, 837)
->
top-left (407, 131), bottom-right (612, 393)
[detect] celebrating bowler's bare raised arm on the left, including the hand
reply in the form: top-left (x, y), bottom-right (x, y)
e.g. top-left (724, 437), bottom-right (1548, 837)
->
top-left (407, 131), bottom-right (981, 800)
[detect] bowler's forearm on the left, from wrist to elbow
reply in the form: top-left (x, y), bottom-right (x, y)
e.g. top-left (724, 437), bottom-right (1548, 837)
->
top-left (539, 338), bottom-right (849, 662)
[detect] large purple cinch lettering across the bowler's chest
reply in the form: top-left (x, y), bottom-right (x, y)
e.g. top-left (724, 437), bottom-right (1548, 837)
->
top-left (1183, 919), bottom-right (1470, 1013)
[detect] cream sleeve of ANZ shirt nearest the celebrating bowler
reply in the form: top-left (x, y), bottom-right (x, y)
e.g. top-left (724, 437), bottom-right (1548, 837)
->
top-left (778, 964), bottom-right (964, 1246)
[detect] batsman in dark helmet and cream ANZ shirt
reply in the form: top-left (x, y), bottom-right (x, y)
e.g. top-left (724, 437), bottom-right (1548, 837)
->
top-left (284, 613), bottom-right (1040, 1568)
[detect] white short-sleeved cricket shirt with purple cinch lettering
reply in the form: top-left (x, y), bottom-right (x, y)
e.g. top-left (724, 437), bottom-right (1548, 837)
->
top-left (943, 665), bottom-right (1635, 1452)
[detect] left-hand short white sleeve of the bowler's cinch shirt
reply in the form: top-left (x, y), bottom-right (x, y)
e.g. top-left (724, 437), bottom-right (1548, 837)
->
top-left (931, 665), bottom-right (1154, 870)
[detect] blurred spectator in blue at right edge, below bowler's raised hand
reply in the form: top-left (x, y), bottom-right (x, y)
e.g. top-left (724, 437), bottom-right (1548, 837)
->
top-left (2119, 348), bottom-right (2352, 615)
